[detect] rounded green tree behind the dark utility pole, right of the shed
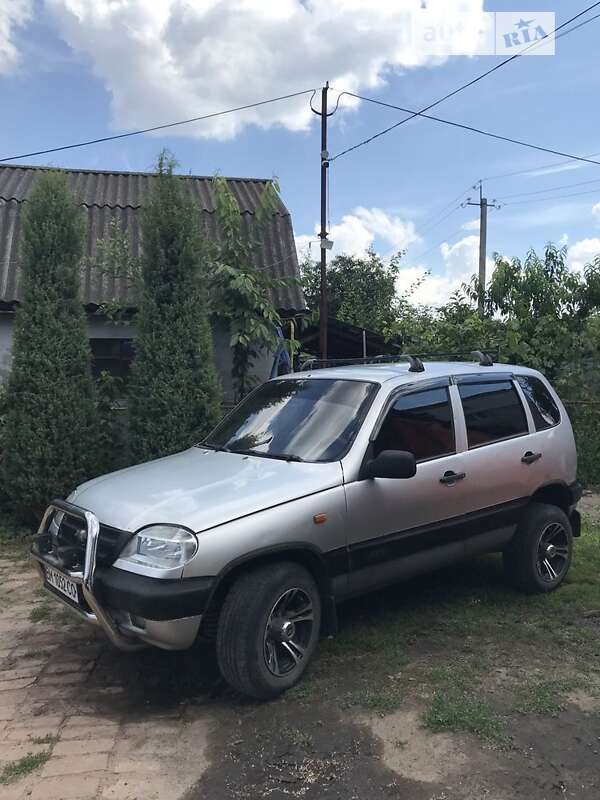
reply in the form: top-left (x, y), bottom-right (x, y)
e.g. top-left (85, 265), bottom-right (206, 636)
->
top-left (300, 250), bottom-right (408, 336)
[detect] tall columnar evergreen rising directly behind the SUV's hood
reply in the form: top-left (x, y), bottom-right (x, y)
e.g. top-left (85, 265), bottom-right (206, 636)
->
top-left (129, 152), bottom-right (221, 461)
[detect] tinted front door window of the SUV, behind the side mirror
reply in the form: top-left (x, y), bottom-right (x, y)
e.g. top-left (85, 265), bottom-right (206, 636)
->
top-left (375, 388), bottom-right (455, 461)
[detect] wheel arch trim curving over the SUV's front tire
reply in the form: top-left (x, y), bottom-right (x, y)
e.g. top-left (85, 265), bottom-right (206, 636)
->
top-left (200, 542), bottom-right (337, 639)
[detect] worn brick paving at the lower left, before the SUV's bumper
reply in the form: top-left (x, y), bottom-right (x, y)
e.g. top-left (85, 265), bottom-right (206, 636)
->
top-left (0, 558), bottom-right (210, 800)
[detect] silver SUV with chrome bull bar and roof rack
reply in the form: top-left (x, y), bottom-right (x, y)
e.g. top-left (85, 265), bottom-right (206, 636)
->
top-left (32, 354), bottom-right (580, 698)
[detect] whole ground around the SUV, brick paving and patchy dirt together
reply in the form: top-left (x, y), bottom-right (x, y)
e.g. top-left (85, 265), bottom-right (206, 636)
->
top-left (0, 495), bottom-right (600, 800)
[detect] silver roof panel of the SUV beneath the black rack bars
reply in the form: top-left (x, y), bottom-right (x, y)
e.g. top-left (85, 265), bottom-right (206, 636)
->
top-left (277, 361), bottom-right (539, 384)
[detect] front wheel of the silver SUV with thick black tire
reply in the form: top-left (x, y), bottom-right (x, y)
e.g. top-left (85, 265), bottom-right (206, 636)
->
top-left (217, 561), bottom-right (321, 700)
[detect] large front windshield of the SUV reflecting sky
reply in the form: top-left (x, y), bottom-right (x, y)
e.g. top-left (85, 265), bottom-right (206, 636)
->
top-left (204, 378), bottom-right (377, 461)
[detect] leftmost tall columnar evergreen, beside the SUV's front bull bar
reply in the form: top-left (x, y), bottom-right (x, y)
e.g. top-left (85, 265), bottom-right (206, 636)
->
top-left (2, 172), bottom-right (97, 523)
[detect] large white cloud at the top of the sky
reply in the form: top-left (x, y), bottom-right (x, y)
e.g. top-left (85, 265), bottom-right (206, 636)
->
top-left (23, 0), bottom-right (483, 139)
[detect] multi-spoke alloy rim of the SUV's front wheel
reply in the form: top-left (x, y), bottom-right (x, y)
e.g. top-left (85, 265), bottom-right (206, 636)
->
top-left (263, 587), bottom-right (314, 678)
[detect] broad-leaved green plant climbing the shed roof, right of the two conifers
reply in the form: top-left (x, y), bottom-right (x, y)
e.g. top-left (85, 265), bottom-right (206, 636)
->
top-left (212, 175), bottom-right (290, 399)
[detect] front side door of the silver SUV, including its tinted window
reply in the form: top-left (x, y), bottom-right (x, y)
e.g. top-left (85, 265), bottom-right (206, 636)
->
top-left (346, 381), bottom-right (469, 592)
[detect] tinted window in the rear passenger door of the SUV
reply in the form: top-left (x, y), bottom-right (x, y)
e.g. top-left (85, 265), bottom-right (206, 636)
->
top-left (458, 381), bottom-right (527, 447)
